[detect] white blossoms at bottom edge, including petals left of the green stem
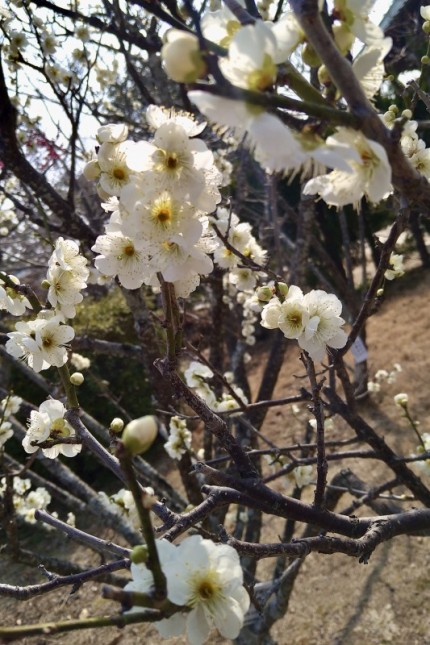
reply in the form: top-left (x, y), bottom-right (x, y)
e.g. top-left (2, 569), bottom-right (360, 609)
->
top-left (124, 535), bottom-right (249, 645)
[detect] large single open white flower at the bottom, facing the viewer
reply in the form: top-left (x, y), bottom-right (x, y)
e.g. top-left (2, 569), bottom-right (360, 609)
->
top-left (164, 535), bottom-right (249, 645)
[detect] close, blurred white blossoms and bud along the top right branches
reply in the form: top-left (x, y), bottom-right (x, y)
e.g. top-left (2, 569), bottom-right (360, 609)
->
top-left (154, 0), bottom-right (416, 207)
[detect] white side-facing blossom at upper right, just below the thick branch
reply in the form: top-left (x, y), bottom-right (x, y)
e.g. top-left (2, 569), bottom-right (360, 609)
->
top-left (303, 128), bottom-right (392, 208)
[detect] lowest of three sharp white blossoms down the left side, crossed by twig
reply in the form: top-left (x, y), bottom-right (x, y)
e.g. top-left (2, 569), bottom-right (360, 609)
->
top-left (22, 399), bottom-right (82, 459)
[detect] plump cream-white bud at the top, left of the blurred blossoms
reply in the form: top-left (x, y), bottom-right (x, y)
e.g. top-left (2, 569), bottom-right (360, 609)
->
top-left (161, 29), bottom-right (206, 83)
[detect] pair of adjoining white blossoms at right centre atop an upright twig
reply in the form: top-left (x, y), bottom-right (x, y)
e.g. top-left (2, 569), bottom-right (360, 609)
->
top-left (260, 285), bottom-right (348, 361)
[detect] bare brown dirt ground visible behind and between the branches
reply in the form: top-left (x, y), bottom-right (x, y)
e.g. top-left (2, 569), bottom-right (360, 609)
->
top-left (0, 269), bottom-right (430, 645)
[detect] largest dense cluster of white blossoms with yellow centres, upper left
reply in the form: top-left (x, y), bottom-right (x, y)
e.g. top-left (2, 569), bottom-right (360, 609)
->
top-left (84, 106), bottom-right (222, 297)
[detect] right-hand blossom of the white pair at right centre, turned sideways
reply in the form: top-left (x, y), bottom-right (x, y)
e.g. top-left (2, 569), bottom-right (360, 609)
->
top-left (298, 289), bottom-right (348, 361)
